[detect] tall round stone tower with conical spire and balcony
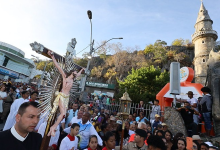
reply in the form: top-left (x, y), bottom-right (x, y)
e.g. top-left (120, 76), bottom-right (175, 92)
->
top-left (192, 2), bottom-right (218, 85)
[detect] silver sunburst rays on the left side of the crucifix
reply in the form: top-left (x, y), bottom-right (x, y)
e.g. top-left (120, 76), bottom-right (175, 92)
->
top-left (39, 60), bottom-right (64, 117)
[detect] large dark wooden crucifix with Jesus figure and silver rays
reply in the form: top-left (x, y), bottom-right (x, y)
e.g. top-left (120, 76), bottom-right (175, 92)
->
top-left (30, 38), bottom-right (84, 150)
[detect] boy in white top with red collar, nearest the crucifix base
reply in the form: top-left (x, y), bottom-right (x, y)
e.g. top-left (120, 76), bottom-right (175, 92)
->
top-left (60, 123), bottom-right (80, 150)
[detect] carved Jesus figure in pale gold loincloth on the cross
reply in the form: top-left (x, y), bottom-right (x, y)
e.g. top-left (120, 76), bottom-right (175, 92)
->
top-left (47, 50), bottom-right (84, 136)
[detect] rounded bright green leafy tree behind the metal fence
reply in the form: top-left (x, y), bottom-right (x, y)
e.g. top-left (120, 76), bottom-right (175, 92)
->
top-left (118, 66), bottom-right (169, 102)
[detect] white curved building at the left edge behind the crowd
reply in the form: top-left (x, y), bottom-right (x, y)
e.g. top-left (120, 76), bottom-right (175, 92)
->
top-left (0, 42), bottom-right (41, 82)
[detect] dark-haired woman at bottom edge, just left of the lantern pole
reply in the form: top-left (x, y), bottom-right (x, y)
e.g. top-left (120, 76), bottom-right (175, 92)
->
top-left (102, 132), bottom-right (115, 150)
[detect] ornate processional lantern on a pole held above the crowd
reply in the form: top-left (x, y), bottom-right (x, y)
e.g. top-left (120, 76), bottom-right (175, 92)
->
top-left (120, 92), bottom-right (132, 150)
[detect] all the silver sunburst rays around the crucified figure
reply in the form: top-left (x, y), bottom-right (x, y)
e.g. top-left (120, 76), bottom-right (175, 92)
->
top-left (39, 56), bottom-right (82, 119)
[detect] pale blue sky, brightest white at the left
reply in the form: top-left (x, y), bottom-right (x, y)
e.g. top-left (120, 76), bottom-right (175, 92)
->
top-left (0, 0), bottom-right (220, 59)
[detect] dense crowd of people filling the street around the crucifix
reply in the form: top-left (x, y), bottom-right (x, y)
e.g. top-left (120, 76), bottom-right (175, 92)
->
top-left (0, 79), bottom-right (218, 150)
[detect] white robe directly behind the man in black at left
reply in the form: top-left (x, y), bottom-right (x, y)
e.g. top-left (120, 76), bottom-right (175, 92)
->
top-left (3, 98), bottom-right (29, 131)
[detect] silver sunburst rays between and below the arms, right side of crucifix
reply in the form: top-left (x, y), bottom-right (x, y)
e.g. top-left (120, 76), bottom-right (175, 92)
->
top-left (65, 55), bottom-right (82, 104)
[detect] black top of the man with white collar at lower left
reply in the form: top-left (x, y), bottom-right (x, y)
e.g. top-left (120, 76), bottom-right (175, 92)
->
top-left (0, 129), bottom-right (42, 150)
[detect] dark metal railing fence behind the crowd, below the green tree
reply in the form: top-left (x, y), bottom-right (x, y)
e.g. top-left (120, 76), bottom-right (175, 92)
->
top-left (88, 101), bottom-right (164, 120)
